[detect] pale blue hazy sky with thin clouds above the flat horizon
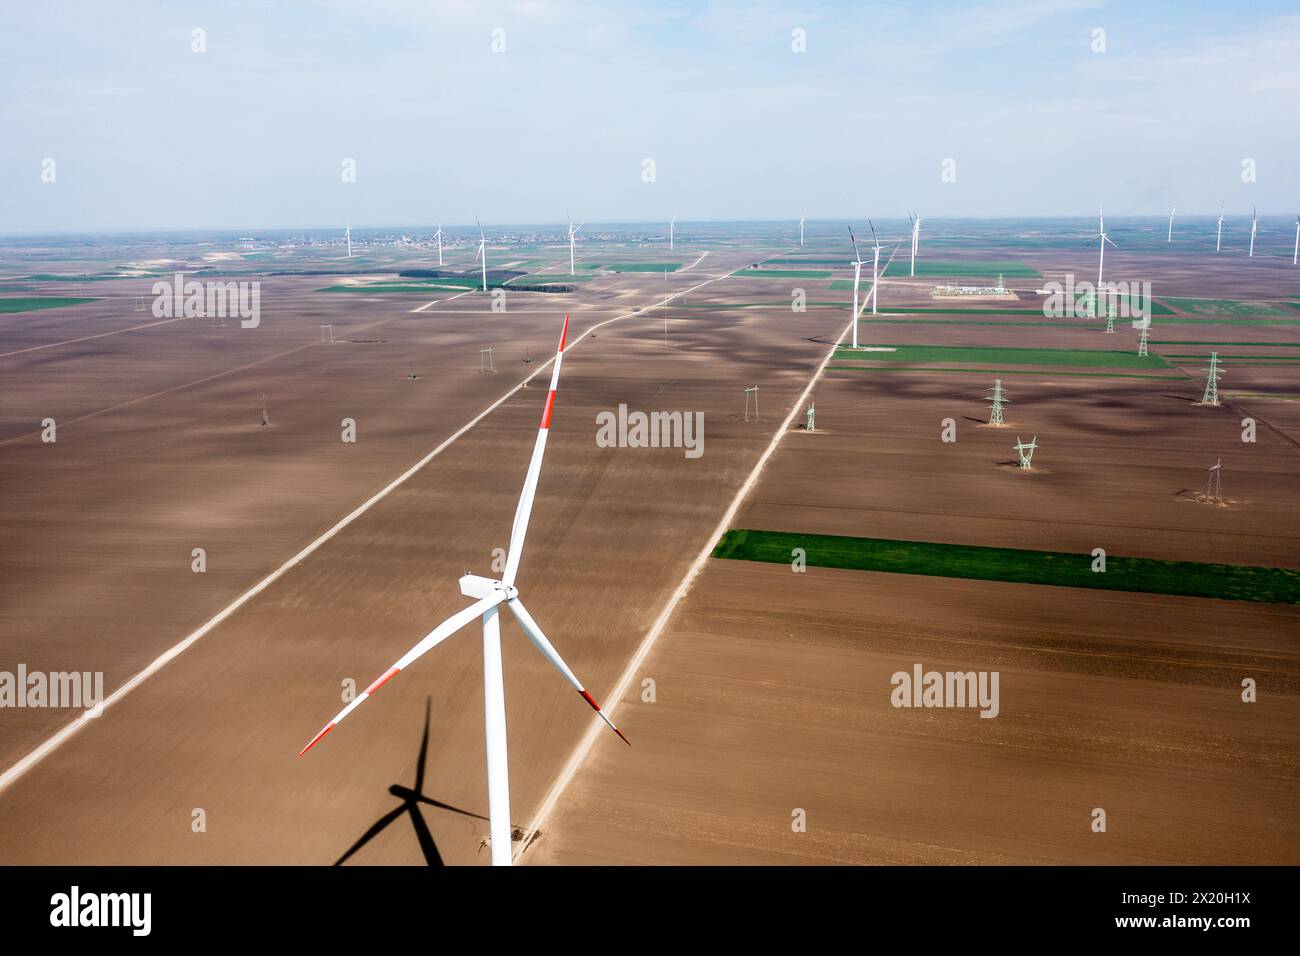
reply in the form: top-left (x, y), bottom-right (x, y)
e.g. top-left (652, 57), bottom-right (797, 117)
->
top-left (0, 0), bottom-right (1300, 234)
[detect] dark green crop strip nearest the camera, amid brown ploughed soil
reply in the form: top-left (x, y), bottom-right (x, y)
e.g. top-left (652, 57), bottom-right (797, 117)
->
top-left (712, 529), bottom-right (1300, 605)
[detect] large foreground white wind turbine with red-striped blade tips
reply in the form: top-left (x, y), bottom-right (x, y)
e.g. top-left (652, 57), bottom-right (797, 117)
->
top-left (298, 315), bottom-right (628, 866)
